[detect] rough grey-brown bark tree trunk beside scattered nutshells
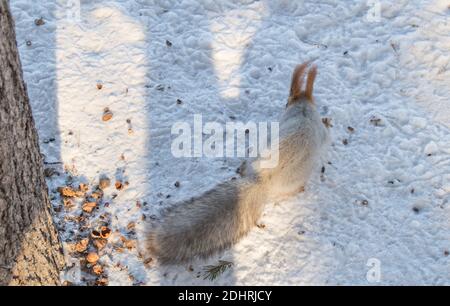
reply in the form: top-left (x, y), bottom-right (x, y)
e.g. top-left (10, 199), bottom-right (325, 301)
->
top-left (0, 0), bottom-right (64, 285)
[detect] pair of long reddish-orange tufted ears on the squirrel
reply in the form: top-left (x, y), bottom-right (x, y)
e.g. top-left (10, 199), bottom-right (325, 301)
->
top-left (288, 61), bottom-right (317, 105)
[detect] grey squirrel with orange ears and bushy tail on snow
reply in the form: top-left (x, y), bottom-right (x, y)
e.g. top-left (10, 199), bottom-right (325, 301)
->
top-left (146, 62), bottom-right (329, 265)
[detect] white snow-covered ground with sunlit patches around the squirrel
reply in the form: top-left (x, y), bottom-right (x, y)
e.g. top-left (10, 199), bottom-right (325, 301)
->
top-left (10, 0), bottom-right (450, 285)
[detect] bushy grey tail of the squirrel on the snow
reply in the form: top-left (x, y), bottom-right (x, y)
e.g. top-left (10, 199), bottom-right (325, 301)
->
top-left (147, 179), bottom-right (266, 264)
